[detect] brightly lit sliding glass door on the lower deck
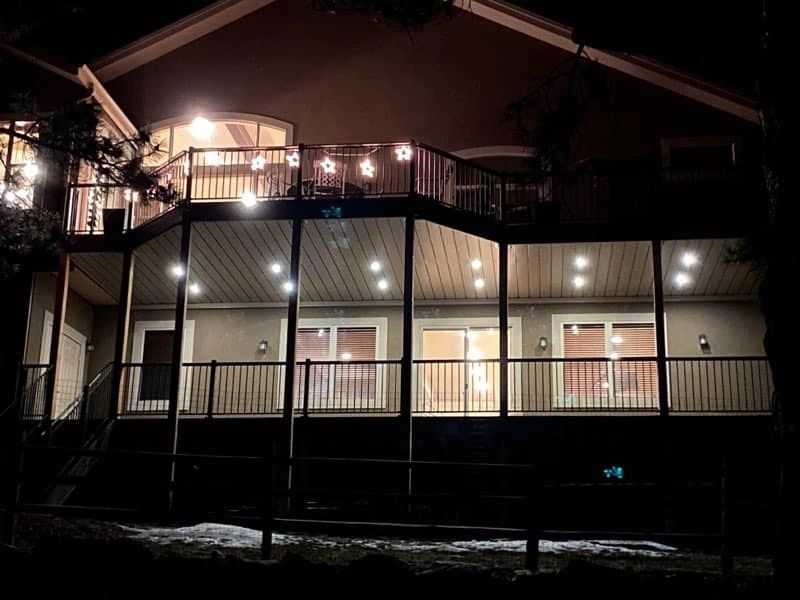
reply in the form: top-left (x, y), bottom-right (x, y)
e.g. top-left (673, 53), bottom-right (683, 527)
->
top-left (417, 327), bottom-right (500, 414)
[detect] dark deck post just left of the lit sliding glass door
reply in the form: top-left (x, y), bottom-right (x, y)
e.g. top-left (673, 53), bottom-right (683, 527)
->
top-left (400, 215), bottom-right (416, 495)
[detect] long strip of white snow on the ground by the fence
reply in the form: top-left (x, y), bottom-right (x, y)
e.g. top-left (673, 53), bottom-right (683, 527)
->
top-left (124, 523), bottom-right (677, 557)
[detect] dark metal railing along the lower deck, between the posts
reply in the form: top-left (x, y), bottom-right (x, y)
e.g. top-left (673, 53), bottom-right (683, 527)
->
top-left (103, 357), bottom-right (773, 417)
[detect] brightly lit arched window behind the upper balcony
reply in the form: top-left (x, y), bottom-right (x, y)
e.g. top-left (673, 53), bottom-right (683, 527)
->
top-left (147, 113), bottom-right (294, 166)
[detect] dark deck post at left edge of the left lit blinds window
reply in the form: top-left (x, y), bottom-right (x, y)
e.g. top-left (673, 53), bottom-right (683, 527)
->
top-left (283, 217), bottom-right (303, 508)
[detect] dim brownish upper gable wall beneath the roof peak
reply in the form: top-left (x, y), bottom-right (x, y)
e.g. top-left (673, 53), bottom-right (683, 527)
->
top-left (107, 0), bottom-right (758, 159)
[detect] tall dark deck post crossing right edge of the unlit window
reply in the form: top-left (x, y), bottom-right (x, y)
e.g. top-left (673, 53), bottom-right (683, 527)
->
top-left (167, 156), bottom-right (194, 512)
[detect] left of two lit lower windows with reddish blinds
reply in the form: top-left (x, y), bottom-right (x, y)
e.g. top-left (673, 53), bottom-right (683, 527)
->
top-left (295, 326), bottom-right (378, 408)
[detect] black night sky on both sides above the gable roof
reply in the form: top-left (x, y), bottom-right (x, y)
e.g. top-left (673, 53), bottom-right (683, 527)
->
top-left (15, 0), bottom-right (760, 93)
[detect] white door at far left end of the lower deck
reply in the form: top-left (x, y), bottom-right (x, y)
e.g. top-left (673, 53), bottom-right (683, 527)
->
top-left (39, 311), bottom-right (86, 418)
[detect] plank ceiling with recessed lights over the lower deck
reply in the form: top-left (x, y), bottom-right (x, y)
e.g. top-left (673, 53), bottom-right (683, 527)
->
top-left (72, 219), bottom-right (757, 305)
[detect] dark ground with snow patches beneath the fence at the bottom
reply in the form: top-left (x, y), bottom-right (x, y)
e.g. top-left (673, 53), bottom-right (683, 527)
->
top-left (0, 516), bottom-right (772, 600)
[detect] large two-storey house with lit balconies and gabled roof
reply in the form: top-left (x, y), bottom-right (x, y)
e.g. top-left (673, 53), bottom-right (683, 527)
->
top-left (1, 0), bottom-right (771, 528)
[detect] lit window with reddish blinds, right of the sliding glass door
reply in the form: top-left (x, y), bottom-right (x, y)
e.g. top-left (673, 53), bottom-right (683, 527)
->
top-left (553, 315), bottom-right (658, 409)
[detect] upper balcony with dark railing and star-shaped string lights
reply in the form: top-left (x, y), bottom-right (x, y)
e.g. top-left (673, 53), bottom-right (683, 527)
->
top-left (67, 142), bottom-right (766, 243)
